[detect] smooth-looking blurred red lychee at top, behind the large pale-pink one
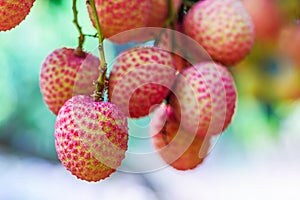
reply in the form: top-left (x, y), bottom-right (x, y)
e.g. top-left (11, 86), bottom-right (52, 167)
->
top-left (243, 0), bottom-right (283, 41)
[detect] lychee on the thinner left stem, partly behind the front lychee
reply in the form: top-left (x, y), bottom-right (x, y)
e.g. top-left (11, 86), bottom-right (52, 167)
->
top-left (40, 48), bottom-right (99, 115)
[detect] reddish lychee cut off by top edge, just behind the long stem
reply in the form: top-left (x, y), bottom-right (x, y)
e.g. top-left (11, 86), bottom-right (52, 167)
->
top-left (87, 0), bottom-right (151, 43)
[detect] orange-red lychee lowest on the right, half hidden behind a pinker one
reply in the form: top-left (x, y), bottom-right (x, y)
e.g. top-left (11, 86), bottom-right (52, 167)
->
top-left (150, 105), bottom-right (210, 170)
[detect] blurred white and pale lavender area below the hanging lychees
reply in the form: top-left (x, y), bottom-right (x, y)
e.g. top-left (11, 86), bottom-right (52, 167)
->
top-left (0, 102), bottom-right (300, 200)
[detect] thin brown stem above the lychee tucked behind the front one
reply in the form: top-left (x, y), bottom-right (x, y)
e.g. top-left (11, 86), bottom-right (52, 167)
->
top-left (72, 0), bottom-right (85, 57)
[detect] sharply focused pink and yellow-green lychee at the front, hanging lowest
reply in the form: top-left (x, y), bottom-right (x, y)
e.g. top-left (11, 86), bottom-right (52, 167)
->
top-left (55, 95), bottom-right (128, 181)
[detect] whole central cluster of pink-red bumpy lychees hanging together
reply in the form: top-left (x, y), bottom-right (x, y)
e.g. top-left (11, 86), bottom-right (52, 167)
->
top-left (39, 0), bottom-right (254, 181)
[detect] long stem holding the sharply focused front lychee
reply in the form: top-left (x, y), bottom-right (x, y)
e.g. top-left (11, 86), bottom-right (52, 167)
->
top-left (87, 0), bottom-right (108, 101)
